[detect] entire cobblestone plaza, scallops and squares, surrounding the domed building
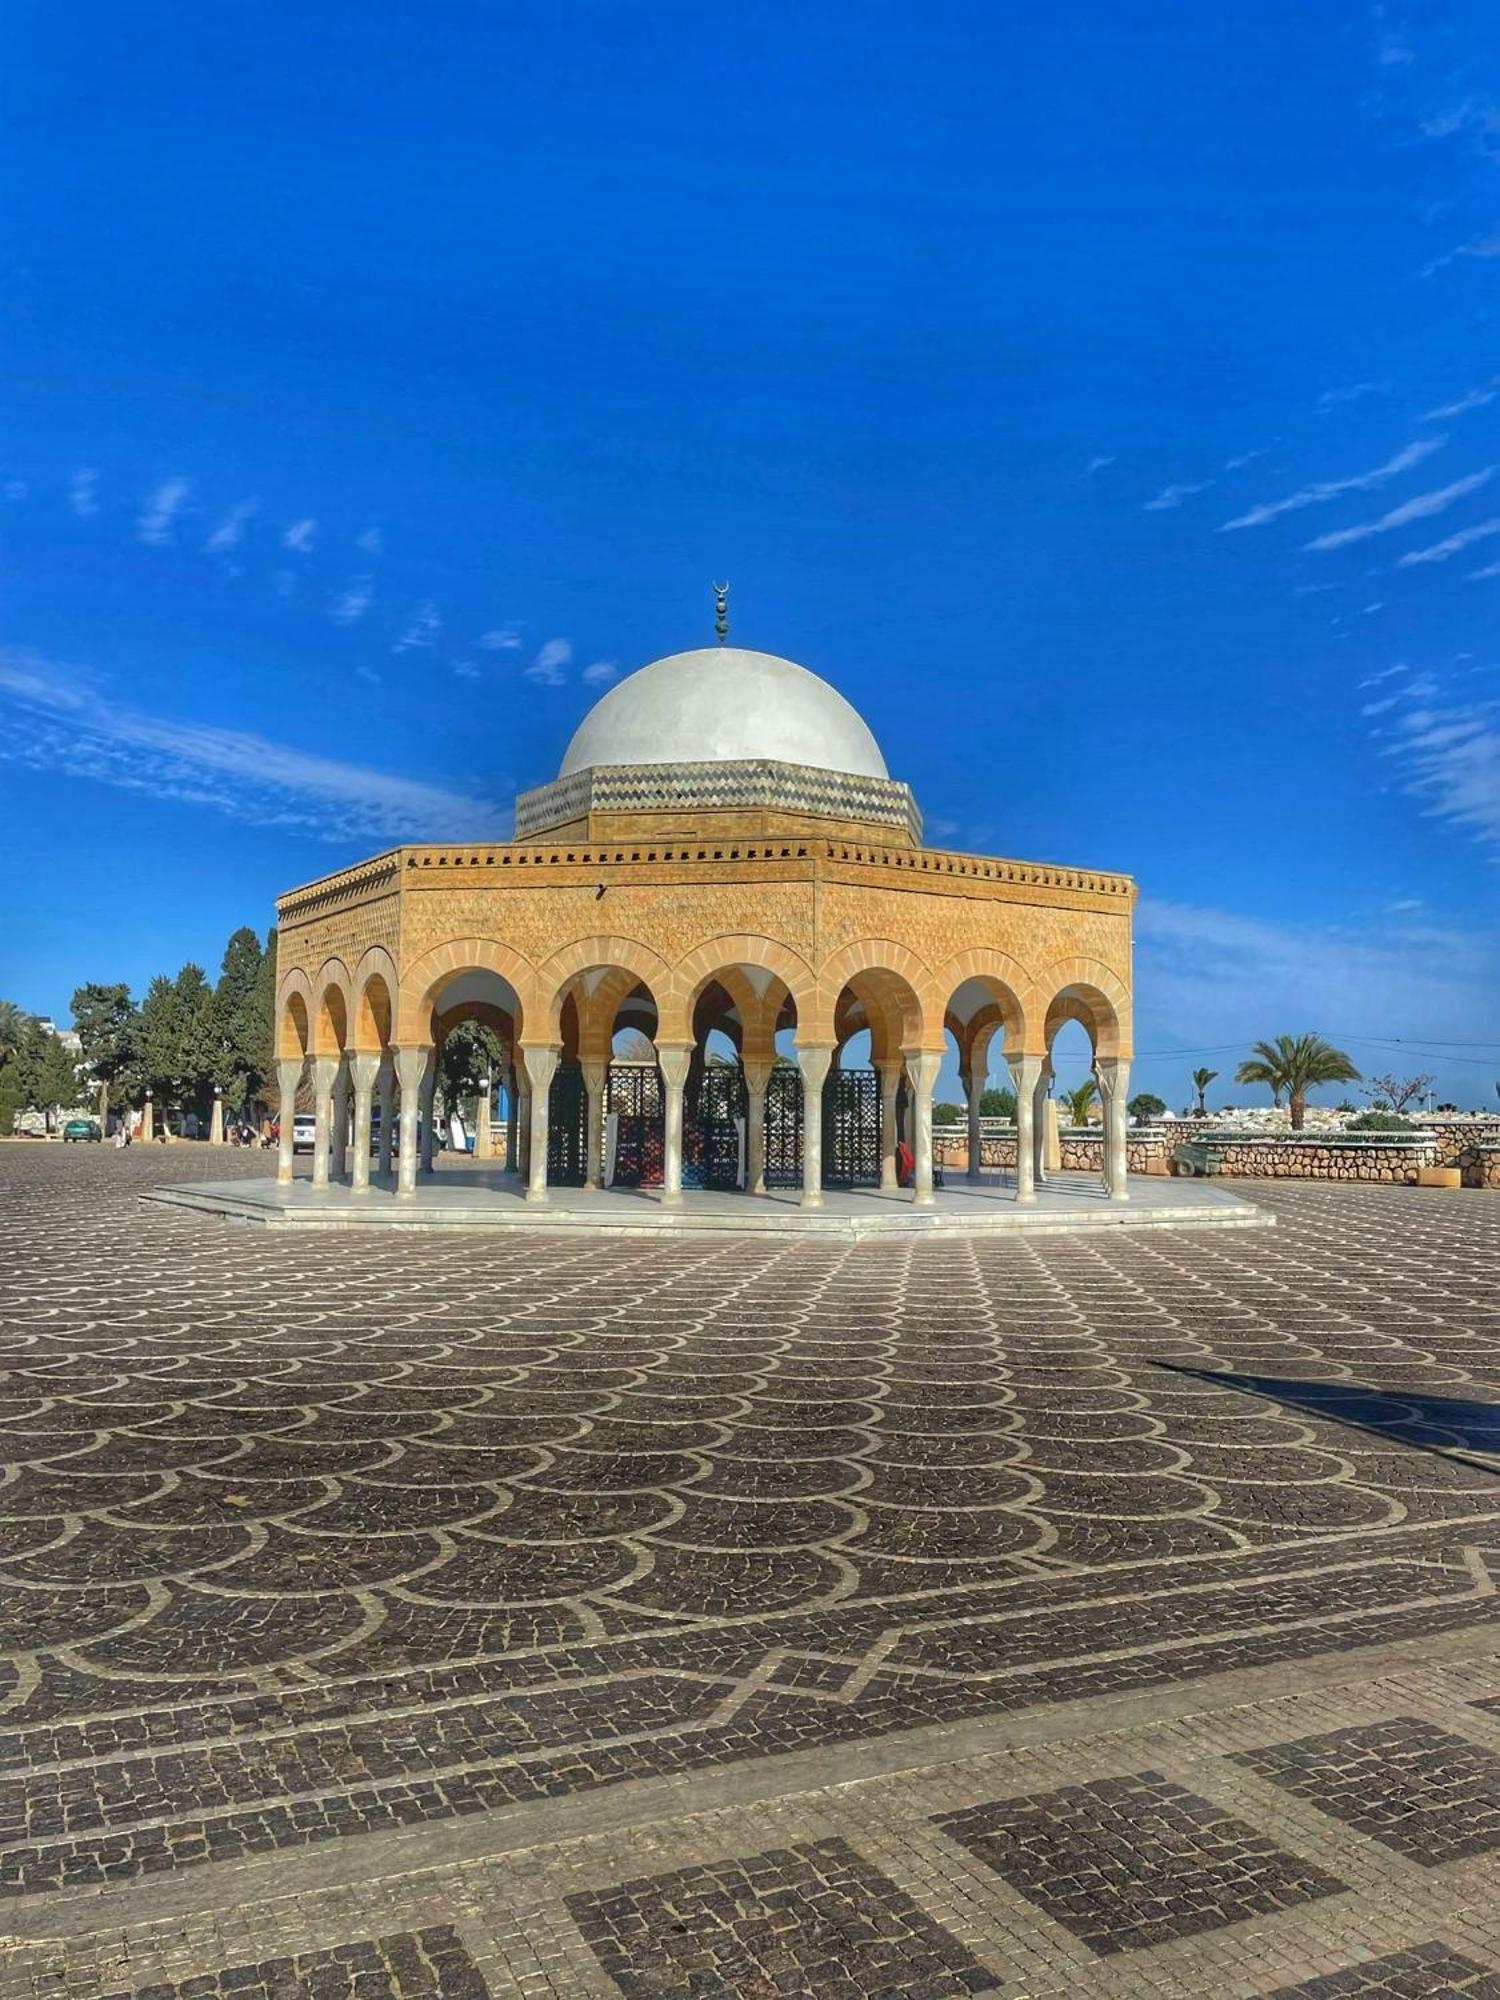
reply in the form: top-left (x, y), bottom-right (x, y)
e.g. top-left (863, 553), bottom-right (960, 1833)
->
top-left (0, 1144), bottom-right (1500, 2000)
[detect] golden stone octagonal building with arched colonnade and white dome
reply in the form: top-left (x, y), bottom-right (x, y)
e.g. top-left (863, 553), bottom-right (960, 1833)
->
top-left (278, 644), bottom-right (1136, 1208)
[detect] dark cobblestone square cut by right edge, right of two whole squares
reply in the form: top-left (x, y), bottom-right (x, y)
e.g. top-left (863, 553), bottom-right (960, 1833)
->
top-left (1240, 1716), bottom-right (1500, 1868)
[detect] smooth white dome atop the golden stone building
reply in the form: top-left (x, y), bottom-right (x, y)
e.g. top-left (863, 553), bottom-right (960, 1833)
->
top-left (558, 646), bottom-right (888, 778)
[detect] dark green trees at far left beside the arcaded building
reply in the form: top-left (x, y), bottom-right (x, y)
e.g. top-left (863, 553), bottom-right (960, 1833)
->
top-left (0, 926), bottom-right (276, 1132)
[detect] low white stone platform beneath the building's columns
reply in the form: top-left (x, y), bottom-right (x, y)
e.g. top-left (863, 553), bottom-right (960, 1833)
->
top-left (142, 1164), bottom-right (1276, 1238)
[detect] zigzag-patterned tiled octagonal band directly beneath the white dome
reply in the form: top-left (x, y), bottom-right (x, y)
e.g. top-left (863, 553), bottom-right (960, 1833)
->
top-left (516, 758), bottom-right (922, 844)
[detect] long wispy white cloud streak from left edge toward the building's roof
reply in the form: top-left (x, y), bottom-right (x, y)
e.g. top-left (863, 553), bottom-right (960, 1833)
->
top-left (0, 648), bottom-right (510, 846)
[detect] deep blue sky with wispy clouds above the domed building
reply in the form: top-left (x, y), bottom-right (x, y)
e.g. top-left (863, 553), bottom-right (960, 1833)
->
top-left (0, 0), bottom-right (1500, 1104)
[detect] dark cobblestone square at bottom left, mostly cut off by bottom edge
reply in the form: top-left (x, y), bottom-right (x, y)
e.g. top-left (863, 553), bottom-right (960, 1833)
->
top-left (94, 1924), bottom-right (490, 2000)
